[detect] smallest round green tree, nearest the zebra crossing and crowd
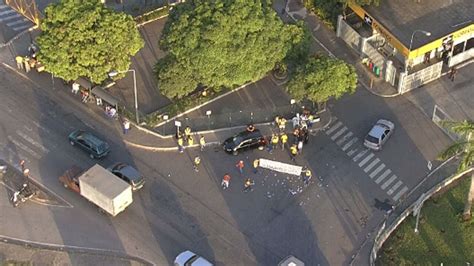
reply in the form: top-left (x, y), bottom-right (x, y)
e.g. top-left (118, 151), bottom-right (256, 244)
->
top-left (287, 56), bottom-right (357, 103)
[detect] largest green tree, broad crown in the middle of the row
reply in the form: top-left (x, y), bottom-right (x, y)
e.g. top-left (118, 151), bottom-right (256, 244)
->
top-left (155, 0), bottom-right (303, 98)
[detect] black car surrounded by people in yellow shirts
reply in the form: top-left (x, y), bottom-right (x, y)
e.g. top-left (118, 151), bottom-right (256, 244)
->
top-left (223, 129), bottom-right (266, 155)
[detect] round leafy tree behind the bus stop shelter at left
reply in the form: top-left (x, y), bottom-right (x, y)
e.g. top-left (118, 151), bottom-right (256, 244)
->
top-left (37, 0), bottom-right (144, 83)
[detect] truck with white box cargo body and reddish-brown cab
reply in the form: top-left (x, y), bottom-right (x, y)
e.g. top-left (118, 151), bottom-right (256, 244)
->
top-left (59, 164), bottom-right (133, 216)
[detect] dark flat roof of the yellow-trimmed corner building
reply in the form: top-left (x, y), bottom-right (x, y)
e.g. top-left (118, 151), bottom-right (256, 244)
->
top-left (363, 0), bottom-right (474, 50)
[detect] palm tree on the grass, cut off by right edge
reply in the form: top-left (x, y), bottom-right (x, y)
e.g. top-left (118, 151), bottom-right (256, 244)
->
top-left (438, 121), bottom-right (474, 221)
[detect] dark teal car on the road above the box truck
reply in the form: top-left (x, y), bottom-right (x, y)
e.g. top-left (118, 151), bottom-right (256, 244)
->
top-left (69, 130), bottom-right (110, 159)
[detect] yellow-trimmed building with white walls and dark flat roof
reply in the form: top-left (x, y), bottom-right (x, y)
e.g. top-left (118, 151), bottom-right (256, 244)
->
top-left (337, 0), bottom-right (474, 93)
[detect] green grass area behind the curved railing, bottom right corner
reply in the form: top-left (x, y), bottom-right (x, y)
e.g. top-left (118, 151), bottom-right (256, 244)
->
top-left (376, 176), bottom-right (474, 265)
